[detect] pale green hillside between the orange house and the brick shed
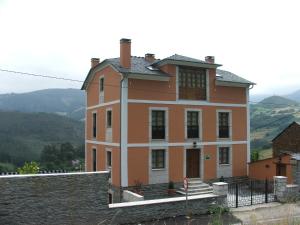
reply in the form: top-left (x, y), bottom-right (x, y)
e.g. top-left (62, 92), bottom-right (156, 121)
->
top-left (250, 96), bottom-right (300, 153)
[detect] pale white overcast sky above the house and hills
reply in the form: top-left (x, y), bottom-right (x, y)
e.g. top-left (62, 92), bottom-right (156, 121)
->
top-left (0, 0), bottom-right (300, 94)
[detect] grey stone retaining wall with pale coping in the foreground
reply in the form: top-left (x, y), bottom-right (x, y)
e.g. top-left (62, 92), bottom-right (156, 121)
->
top-left (0, 171), bottom-right (226, 225)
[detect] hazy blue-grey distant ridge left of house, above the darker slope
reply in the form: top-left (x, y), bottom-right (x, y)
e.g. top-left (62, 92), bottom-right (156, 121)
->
top-left (0, 89), bottom-right (85, 120)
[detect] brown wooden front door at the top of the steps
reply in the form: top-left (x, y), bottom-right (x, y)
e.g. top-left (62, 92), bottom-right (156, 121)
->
top-left (186, 149), bottom-right (200, 178)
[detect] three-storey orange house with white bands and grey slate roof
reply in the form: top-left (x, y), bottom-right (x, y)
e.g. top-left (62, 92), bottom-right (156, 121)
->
top-left (82, 39), bottom-right (253, 201)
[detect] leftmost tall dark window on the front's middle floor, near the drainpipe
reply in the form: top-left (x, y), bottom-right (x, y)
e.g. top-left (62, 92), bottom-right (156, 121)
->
top-left (151, 110), bottom-right (166, 139)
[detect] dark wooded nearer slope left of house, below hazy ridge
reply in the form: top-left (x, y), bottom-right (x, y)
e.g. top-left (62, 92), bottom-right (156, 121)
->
top-left (0, 112), bottom-right (84, 166)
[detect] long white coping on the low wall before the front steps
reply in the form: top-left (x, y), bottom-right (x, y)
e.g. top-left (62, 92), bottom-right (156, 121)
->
top-left (108, 194), bottom-right (219, 208)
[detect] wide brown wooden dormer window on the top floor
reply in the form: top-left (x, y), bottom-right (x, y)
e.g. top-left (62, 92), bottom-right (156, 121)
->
top-left (178, 67), bottom-right (207, 100)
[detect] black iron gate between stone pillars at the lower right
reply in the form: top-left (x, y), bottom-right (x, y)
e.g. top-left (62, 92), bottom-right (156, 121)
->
top-left (227, 180), bottom-right (275, 208)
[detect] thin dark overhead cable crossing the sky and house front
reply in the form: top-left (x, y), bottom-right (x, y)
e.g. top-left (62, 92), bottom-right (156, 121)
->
top-left (0, 68), bottom-right (298, 106)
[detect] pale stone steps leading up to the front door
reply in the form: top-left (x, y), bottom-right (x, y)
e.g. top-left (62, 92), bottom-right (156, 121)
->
top-left (177, 178), bottom-right (213, 196)
